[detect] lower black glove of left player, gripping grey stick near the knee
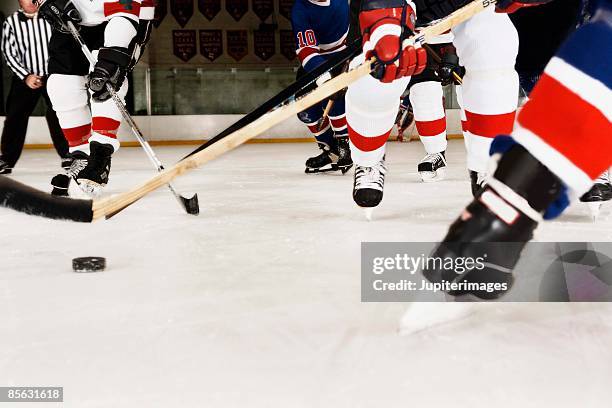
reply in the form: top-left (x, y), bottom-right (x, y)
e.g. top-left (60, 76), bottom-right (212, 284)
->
top-left (88, 47), bottom-right (132, 102)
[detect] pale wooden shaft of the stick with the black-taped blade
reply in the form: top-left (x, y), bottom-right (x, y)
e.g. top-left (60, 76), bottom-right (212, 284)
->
top-left (92, 0), bottom-right (496, 220)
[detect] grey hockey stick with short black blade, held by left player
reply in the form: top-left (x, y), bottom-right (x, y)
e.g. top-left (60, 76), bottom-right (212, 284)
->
top-left (67, 21), bottom-right (200, 215)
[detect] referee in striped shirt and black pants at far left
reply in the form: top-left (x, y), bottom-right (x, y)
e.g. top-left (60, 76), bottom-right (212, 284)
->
top-left (0, 0), bottom-right (69, 174)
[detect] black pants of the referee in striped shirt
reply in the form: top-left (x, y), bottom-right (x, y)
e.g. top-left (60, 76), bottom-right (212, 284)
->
top-left (0, 76), bottom-right (68, 167)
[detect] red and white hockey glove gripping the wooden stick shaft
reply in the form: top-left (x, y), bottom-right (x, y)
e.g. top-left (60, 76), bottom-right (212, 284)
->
top-left (359, 0), bottom-right (427, 83)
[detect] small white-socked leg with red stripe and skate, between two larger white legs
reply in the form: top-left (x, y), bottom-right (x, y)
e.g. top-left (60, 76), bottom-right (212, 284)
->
top-left (410, 81), bottom-right (447, 182)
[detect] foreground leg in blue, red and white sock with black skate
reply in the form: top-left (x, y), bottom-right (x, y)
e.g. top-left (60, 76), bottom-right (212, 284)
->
top-left (425, 10), bottom-right (612, 295)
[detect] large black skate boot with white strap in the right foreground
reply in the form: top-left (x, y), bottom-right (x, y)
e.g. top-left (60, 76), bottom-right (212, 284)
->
top-left (423, 145), bottom-right (562, 299)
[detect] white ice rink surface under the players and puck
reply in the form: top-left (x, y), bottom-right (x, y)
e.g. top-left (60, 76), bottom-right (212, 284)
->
top-left (0, 141), bottom-right (612, 408)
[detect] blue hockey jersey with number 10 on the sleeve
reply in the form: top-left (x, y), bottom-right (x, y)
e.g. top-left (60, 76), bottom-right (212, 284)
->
top-left (291, 0), bottom-right (350, 71)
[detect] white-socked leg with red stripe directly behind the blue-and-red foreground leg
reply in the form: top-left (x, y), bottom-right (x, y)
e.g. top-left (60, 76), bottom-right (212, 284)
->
top-left (453, 9), bottom-right (519, 195)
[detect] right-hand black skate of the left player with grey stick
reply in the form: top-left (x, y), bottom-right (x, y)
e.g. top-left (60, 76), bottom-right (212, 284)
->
top-left (74, 142), bottom-right (115, 197)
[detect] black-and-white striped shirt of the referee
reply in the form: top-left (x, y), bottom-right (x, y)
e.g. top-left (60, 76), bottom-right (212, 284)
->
top-left (1, 11), bottom-right (51, 80)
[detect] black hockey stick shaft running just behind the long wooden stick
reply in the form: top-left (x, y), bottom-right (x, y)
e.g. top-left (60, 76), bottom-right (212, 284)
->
top-left (181, 39), bottom-right (361, 160)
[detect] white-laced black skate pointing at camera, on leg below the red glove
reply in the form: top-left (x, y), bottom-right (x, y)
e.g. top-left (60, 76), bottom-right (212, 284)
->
top-left (353, 157), bottom-right (387, 219)
